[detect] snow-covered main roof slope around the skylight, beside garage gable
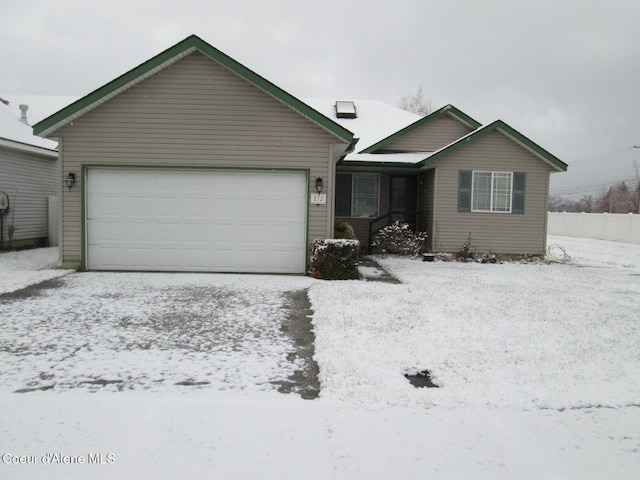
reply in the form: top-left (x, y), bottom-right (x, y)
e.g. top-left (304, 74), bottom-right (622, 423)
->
top-left (301, 97), bottom-right (424, 160)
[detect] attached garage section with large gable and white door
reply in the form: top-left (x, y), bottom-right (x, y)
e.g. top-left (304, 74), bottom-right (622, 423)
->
top-left (34, 35), bottom-right (356, 274)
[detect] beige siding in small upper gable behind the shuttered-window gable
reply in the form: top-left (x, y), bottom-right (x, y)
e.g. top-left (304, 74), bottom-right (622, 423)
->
top-left (384, 114), bottom-right (472, 152)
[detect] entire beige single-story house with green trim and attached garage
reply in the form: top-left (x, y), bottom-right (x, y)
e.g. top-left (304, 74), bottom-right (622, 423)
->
top-left (34, 36), bottom-right (566, 274)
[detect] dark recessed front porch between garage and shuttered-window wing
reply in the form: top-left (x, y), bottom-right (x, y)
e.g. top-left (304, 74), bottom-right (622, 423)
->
top-left (335, 166), bottom-right (436, 253)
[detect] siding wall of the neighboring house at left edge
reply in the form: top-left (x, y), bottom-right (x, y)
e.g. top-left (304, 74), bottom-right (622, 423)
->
top-left (0, 147), bottom-right (60, 246)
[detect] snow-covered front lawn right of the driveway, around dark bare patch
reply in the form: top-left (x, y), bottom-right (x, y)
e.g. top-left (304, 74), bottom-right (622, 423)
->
top-left (310, 238), bottom-right (640, 408)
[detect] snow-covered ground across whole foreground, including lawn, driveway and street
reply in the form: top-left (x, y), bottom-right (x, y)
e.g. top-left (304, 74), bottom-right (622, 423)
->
top-left (0, 237), bottom-right (640, 479)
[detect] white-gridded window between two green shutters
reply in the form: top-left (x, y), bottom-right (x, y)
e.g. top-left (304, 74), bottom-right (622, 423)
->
top-left (471, 172), bottom-right (513, 213)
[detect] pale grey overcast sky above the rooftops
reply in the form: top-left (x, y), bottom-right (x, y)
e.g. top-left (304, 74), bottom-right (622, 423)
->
top-left (0, 0), bottom-right (640, 197)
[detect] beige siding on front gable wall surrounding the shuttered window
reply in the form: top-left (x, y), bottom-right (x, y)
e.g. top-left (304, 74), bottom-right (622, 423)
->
top-left (434, 131), bottom-right (551, 255)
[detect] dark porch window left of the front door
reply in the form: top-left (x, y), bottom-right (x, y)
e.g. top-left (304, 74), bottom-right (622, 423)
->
top-left (336, 173), bottom-right (380, 218)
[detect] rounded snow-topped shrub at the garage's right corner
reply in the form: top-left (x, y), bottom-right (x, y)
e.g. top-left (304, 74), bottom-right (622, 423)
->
top-left (309, 239), bottom-right (360, 280)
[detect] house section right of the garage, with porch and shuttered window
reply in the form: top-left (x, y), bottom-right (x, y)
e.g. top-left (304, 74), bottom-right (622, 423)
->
top-left (309, 99), bottom-right (567, 255)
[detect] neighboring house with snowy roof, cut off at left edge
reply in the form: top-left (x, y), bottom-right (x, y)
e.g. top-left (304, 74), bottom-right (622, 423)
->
top-left (0, 97), bottom-right (60, 249)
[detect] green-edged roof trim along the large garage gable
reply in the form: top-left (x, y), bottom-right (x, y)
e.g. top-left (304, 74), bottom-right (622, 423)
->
top-left (33, 35), bottom-right (353, 144)
